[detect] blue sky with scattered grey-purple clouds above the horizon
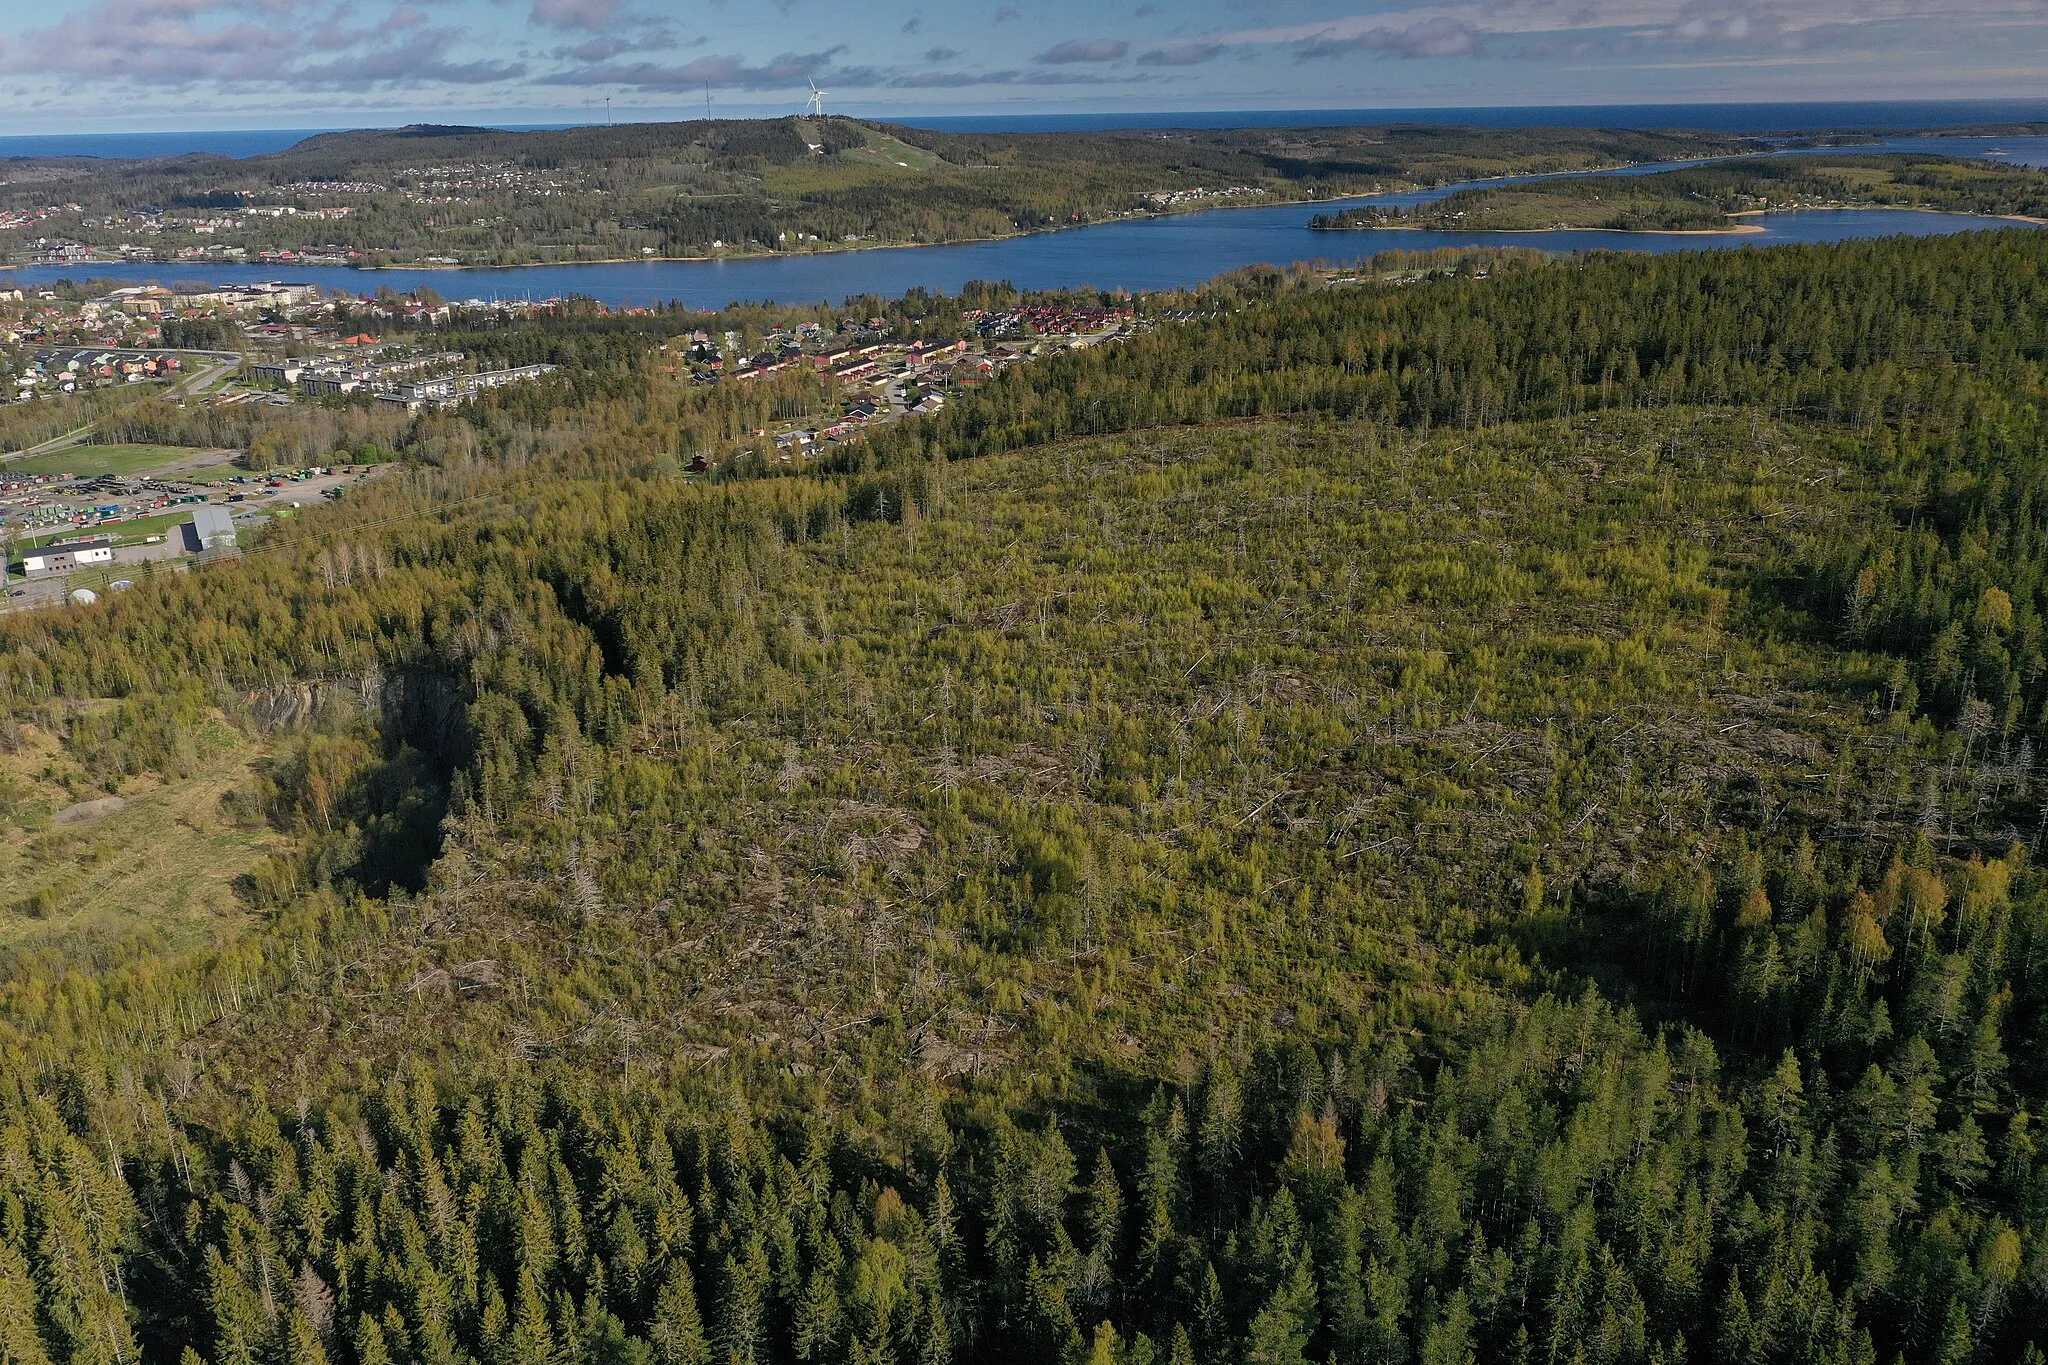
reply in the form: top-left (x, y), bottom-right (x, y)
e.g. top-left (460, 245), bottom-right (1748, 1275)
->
top-left (0, 0), bottom-right (2048, 133)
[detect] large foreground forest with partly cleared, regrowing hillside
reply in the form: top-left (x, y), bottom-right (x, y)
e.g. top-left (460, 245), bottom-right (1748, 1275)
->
top-left (0, 229), bottom-right (2048, 1365)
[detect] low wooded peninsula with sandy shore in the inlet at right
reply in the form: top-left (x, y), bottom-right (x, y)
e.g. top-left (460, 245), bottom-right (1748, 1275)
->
top-left (1309, 151), bottom-right (2048, 231)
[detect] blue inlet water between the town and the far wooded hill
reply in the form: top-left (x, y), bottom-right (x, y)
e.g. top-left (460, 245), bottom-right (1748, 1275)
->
top-left (0, 137), bottom-right (2048, 309)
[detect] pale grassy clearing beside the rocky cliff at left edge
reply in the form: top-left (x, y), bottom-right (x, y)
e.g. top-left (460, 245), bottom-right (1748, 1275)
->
top-left (0, 722), bottom-right (287, 950)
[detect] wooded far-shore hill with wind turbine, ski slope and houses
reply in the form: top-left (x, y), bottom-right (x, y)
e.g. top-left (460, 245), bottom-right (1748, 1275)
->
top-left (0, 117), bottom-right (1751, 266)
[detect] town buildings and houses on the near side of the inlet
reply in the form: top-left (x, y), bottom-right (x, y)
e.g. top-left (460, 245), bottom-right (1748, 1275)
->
top-left (0, 270), bottom-right (1188, 610)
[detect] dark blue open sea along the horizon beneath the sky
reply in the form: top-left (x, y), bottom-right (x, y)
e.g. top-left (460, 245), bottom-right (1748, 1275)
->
top-left (0, 100), bottom-right (2048, 160)
